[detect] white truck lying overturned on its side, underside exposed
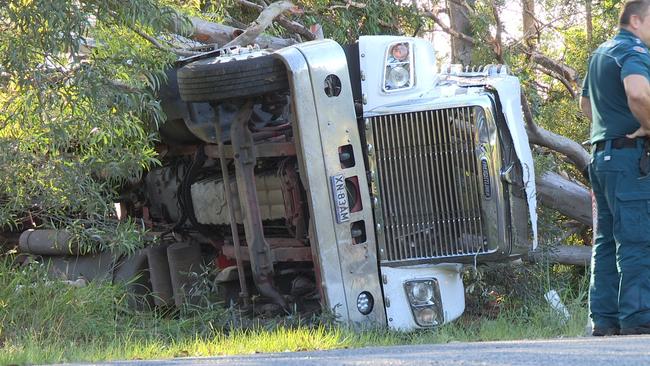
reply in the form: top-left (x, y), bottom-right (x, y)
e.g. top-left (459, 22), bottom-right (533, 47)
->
top-left (21, 36), bottom-right (536, 330)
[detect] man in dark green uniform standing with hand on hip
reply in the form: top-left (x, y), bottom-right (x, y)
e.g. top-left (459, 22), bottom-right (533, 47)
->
top-left (580, 0), bottom-right (650, 336)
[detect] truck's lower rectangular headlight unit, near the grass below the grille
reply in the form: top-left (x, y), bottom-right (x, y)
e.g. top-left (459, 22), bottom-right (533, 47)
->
top-left (404, 278), bottom-right (444, 327)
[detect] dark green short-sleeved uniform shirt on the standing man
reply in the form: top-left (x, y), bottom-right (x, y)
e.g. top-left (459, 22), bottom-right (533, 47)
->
top-left (582, 29), bottom-right (650, 143)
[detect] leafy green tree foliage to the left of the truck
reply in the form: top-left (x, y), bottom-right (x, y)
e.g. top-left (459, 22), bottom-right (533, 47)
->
top-left (0, 0), bottom-right (187, 249)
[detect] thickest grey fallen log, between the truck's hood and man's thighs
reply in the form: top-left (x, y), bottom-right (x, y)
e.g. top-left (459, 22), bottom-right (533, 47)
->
top-left (537, 172), bottom-right (593, 226)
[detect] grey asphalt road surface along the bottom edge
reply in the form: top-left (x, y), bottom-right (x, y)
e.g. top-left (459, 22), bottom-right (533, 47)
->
top-left (95, 336), bottom-right (650, 366)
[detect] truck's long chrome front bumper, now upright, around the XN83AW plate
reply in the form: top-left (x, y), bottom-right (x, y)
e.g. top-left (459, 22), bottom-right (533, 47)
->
top-left (276, 40), bottom-right (386, 325)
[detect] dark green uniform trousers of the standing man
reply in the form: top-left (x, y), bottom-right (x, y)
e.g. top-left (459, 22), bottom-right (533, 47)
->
top-left (589, 142), bottom-right (650, 328)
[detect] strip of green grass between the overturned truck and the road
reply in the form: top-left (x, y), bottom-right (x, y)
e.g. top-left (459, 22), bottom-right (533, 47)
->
top-left (0, 260), bottom-right (587, 365)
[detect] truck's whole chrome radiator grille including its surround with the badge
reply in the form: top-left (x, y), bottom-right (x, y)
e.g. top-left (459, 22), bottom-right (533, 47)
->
top-left (366, 95), bottom-right (510, 266)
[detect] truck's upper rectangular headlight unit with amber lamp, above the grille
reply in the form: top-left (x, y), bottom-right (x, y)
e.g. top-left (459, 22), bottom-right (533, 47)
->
top-left (383, 42), bottom-right (413, 92)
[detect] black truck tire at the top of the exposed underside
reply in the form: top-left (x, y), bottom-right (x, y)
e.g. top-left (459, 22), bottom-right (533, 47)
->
top-left (178, 55), bottom-right (289, 102)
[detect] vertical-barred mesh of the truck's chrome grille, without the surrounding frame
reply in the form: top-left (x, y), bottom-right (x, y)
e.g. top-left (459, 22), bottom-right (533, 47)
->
top-left (369, 107), bottom-right (487, 262)
